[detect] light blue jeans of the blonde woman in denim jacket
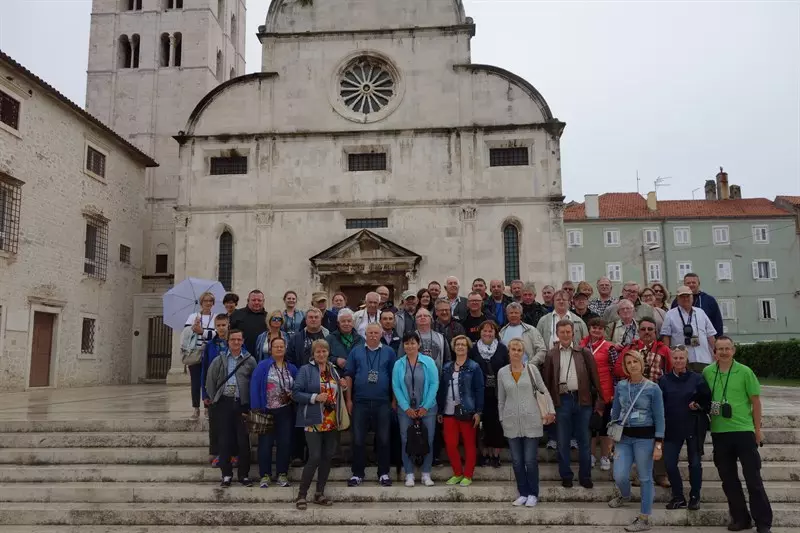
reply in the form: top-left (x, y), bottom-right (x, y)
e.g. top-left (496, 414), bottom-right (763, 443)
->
top-left (614, 435), bottom-right (655, 516)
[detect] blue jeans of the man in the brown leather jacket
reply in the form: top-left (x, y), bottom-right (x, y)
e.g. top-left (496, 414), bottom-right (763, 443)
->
top-left (556, 393), bottom-right (592, 481)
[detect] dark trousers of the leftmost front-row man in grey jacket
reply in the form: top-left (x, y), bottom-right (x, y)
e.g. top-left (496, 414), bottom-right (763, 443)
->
top-left (213, 396), bottom-right (250, 480)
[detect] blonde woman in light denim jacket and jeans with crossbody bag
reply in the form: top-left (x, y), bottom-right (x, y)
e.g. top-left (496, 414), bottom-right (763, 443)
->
top-left (608, 351), bottom-right (664, 531)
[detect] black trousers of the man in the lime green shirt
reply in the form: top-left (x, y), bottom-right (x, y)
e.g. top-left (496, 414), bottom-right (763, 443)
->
top-left (711, 431), bottom-right (772, 527)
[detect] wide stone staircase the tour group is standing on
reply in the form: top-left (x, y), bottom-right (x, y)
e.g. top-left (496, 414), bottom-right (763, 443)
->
top-left (0, 415), bottom-right (800, 533)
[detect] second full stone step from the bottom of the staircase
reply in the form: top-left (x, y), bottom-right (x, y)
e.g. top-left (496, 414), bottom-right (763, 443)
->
top-left (0, 478), bottom-right (800, 504)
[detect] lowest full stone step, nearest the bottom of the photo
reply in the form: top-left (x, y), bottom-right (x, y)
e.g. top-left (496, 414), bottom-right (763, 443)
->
top-left (0, 502), bottom-right (800, 527)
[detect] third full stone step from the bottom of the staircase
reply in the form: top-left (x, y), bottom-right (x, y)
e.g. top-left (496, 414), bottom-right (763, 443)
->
top-left (0, 461), bottom-right (800, 483)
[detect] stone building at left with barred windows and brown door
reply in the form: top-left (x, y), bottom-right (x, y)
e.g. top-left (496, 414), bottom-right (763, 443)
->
top-left (0, 52), bottom-right (158, 390)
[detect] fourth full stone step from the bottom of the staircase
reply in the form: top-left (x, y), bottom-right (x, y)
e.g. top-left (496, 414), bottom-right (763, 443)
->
top-left (0, 444), bottom-right (800, 466)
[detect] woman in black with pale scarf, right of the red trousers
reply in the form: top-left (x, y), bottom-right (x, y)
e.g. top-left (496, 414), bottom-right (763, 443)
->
top-left (469, 320), bottom-right (510, 468)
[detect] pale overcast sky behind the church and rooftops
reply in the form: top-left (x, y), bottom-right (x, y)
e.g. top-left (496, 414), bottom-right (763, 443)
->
top-left (0, 0), bottom-right (800, 200)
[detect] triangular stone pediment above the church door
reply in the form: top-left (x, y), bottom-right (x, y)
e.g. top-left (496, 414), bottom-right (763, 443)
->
top-left (310, 230), bottom-right (422, 276)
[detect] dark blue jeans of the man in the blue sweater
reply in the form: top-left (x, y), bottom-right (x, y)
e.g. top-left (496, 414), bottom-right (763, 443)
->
top-left (351, 400), bottom-right (392, 478)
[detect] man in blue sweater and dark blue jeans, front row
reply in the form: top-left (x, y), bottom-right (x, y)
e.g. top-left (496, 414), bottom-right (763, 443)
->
top-left (345, 322), bottom-right (397, 487)
